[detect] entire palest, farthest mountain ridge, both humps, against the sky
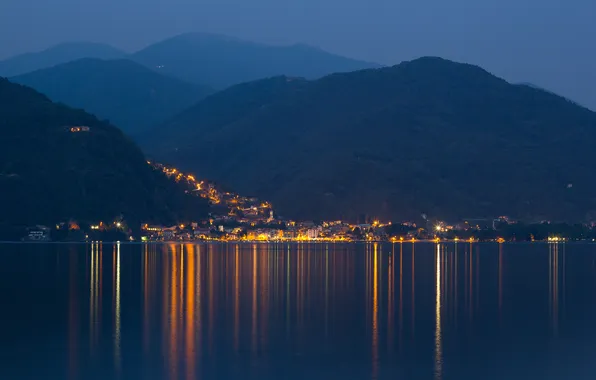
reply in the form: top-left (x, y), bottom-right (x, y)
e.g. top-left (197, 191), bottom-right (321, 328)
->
top-left (0, 33), bottom-right (381, 89)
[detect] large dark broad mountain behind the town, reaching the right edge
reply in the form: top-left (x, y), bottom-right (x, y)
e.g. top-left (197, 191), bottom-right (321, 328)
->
top-left (142, 57), bottom-right (596, 221)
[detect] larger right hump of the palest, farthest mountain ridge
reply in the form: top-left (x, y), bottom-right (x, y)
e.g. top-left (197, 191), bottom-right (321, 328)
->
top-left (132, 33), bottom-right (378, 89)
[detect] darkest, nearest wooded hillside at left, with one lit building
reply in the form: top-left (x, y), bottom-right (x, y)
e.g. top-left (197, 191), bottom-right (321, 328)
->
top-left (0, 75), bottom-right (207, 226)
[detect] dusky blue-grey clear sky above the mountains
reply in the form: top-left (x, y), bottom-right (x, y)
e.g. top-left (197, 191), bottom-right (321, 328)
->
top-left (0, 0), bottom-right (596, 109)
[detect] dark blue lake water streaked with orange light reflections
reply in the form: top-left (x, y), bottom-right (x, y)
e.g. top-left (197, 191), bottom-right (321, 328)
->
top-left (0, 243), bottom-right (596, 380)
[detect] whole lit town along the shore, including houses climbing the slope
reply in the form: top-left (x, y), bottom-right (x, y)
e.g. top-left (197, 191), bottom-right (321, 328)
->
top-left (23, 162), bottom-right (596, 243)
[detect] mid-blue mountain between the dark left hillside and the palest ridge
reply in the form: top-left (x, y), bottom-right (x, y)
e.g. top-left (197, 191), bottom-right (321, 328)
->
top-left (11, 58), bottom-right (212, 134)
